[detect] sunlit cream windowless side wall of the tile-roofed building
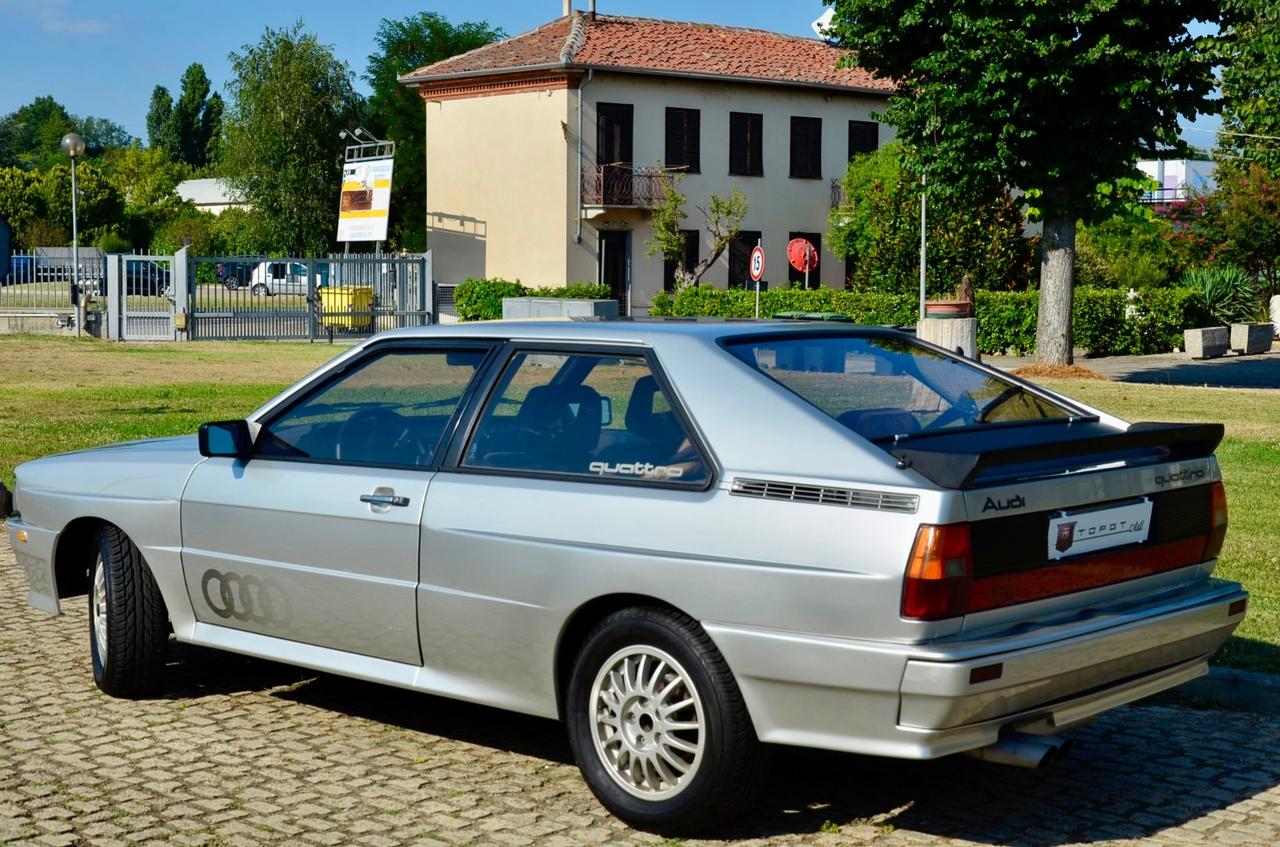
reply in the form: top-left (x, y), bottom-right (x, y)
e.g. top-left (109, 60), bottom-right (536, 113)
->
top-left (426, 90), bottom-right (577, 285)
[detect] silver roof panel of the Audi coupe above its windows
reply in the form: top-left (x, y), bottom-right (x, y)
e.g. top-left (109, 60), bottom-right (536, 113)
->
top-left (374, 317), bottom-right (905, 344)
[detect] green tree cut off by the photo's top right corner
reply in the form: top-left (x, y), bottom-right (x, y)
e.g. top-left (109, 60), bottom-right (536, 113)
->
top-left (1217, 0), bottom-right (1280, 177)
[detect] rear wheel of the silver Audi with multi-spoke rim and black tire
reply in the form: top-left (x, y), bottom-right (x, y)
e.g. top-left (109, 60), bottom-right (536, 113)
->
top-left (566, 608), bottom-right (764, 834)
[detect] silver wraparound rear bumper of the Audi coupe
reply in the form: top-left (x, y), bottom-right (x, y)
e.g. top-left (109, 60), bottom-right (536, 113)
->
top-left (707, 580), bottom-right (1248, 759)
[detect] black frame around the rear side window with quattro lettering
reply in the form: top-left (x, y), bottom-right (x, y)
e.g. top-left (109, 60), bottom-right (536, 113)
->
top-left (439, 340), bottom-right (721, 491)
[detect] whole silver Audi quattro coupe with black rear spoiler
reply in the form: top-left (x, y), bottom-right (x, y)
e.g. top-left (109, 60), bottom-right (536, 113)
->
top-left (8, 321), bottom-right (1247, 832)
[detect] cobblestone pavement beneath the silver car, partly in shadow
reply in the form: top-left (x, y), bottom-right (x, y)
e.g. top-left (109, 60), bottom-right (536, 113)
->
top-left (0, 534), bottom-right (1280, 847)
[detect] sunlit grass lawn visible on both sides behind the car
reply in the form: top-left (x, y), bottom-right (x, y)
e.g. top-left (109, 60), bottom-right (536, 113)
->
top-left (0, 335), bottom-right (1280, 673)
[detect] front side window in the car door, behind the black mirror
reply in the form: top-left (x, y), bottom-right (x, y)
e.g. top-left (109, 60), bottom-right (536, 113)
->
top-left (257, 349), bottom-right (488, 467)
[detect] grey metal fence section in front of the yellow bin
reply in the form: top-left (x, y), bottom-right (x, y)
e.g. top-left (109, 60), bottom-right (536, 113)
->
top-left (187, 253), bottom-right (433, 340)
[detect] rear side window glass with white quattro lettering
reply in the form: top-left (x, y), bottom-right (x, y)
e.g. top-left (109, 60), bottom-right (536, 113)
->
top-left (462, 352), bottom-right (710, 487)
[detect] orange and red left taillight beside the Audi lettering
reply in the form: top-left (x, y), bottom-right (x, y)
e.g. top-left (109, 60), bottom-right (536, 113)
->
top-left (902, 523), bottom-right (973, 621)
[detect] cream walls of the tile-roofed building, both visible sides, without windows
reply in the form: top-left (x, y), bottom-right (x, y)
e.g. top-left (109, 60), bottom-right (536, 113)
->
top-left (426, 73), bottom-right (893, 313)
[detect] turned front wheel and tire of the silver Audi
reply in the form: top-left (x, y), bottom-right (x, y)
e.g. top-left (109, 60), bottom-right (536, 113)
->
top-left (88, 527), bottom-right (169, 699)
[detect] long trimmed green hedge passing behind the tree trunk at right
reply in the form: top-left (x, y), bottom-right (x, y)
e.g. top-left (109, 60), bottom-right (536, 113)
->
top-left (650, 285), bottom-right (1212, 356)
